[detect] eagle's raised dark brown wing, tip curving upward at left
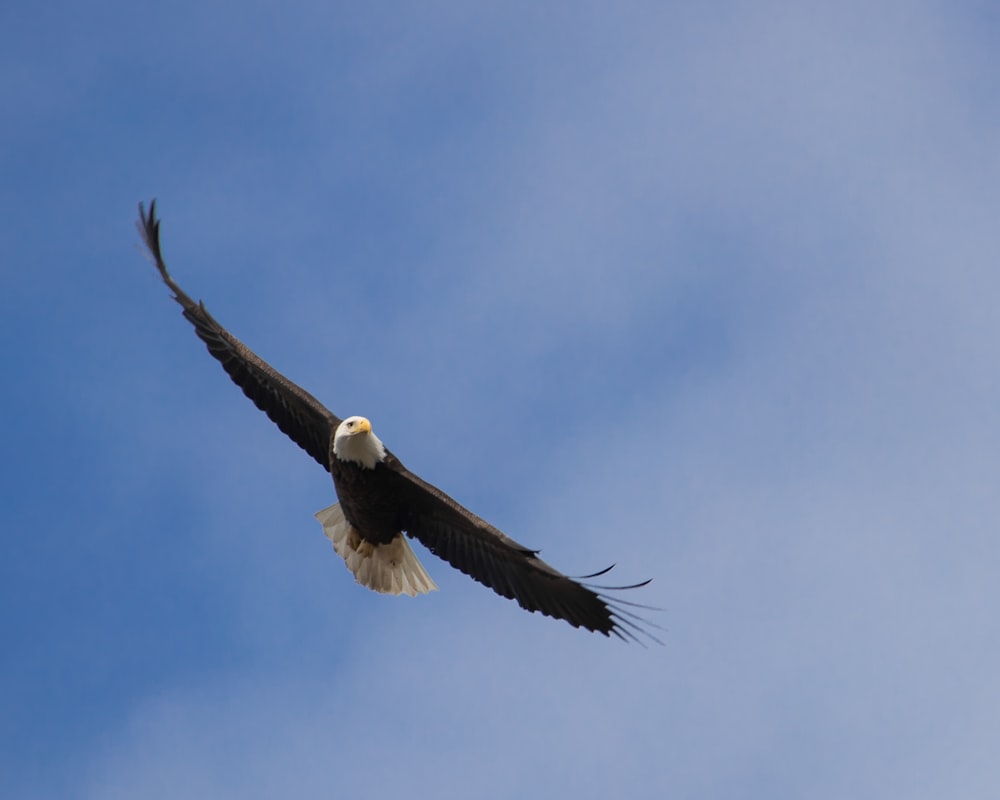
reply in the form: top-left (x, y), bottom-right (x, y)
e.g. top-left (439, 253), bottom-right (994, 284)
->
top-left (136, 200), bottom-right (340, 469)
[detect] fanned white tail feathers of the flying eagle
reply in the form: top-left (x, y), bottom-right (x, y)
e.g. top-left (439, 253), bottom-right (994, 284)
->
top-left (316, 503), bottom-right (437, 597)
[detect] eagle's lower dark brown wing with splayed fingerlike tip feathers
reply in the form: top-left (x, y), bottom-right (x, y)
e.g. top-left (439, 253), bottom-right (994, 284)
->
top-left (385, 456), bottom-right (657, 641)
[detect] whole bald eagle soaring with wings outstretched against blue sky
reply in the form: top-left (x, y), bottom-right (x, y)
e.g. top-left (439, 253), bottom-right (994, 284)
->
top-left (137, 200), bottom-right (656, 641)
